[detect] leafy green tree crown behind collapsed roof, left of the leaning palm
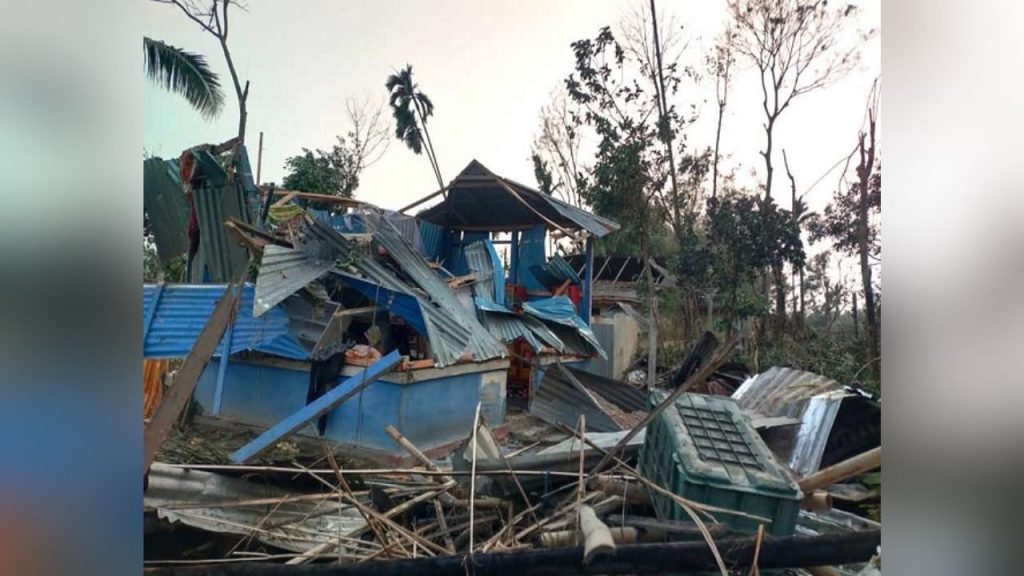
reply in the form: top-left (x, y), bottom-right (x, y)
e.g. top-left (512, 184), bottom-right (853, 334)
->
top-left (284, 136), bottom-right (360, 203)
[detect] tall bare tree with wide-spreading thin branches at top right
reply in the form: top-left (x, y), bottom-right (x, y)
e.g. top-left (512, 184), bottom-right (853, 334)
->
top-left (729, 0), bottom-right (873, 334)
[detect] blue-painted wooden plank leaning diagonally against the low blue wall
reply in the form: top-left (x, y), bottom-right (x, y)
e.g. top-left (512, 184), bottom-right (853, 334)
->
top-left (231, 349), bottom-right (401, 464)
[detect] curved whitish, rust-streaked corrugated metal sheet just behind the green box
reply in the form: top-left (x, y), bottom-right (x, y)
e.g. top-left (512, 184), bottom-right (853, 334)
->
top-left (732, 367), bottom-right (852, 475)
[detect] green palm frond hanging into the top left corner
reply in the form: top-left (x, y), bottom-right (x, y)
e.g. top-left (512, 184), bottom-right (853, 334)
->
top-left (142, 36), bottom-right (224, 119)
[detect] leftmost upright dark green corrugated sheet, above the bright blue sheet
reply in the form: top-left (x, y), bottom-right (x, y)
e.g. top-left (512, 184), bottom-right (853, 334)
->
top-left (142, 158), bottom-right (189, 258)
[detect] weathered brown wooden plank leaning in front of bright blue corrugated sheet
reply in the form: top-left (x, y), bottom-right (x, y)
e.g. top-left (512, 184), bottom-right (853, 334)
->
top-left (142, 284), bottom-right (242, 475)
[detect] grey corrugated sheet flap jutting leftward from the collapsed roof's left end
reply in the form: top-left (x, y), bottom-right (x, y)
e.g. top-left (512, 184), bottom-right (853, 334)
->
top-left (253, 244), bottom-right (335, 318)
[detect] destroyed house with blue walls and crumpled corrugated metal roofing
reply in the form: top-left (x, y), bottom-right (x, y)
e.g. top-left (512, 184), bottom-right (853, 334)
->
top-left (143, 142), bottom-right (618, 459)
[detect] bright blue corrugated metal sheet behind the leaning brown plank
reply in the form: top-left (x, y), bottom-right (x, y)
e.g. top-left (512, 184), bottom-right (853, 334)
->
top-left (142, 284), bottom-right (308, 360)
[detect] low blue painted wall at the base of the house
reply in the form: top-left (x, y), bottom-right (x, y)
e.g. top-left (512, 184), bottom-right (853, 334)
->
top-left (195, 360), bottom-right (505, 457)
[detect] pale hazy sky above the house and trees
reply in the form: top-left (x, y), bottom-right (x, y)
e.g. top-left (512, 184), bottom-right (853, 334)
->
top-left (143, 0), bottom-right (881, 274)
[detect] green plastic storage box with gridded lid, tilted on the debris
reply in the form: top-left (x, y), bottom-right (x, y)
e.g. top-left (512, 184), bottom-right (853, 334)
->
top-left (640, 390), bottom-right (803, 536)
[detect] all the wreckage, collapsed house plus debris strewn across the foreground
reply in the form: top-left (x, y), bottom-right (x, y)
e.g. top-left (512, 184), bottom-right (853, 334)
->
top-left (142, 141), bottom-right (881, 575)
